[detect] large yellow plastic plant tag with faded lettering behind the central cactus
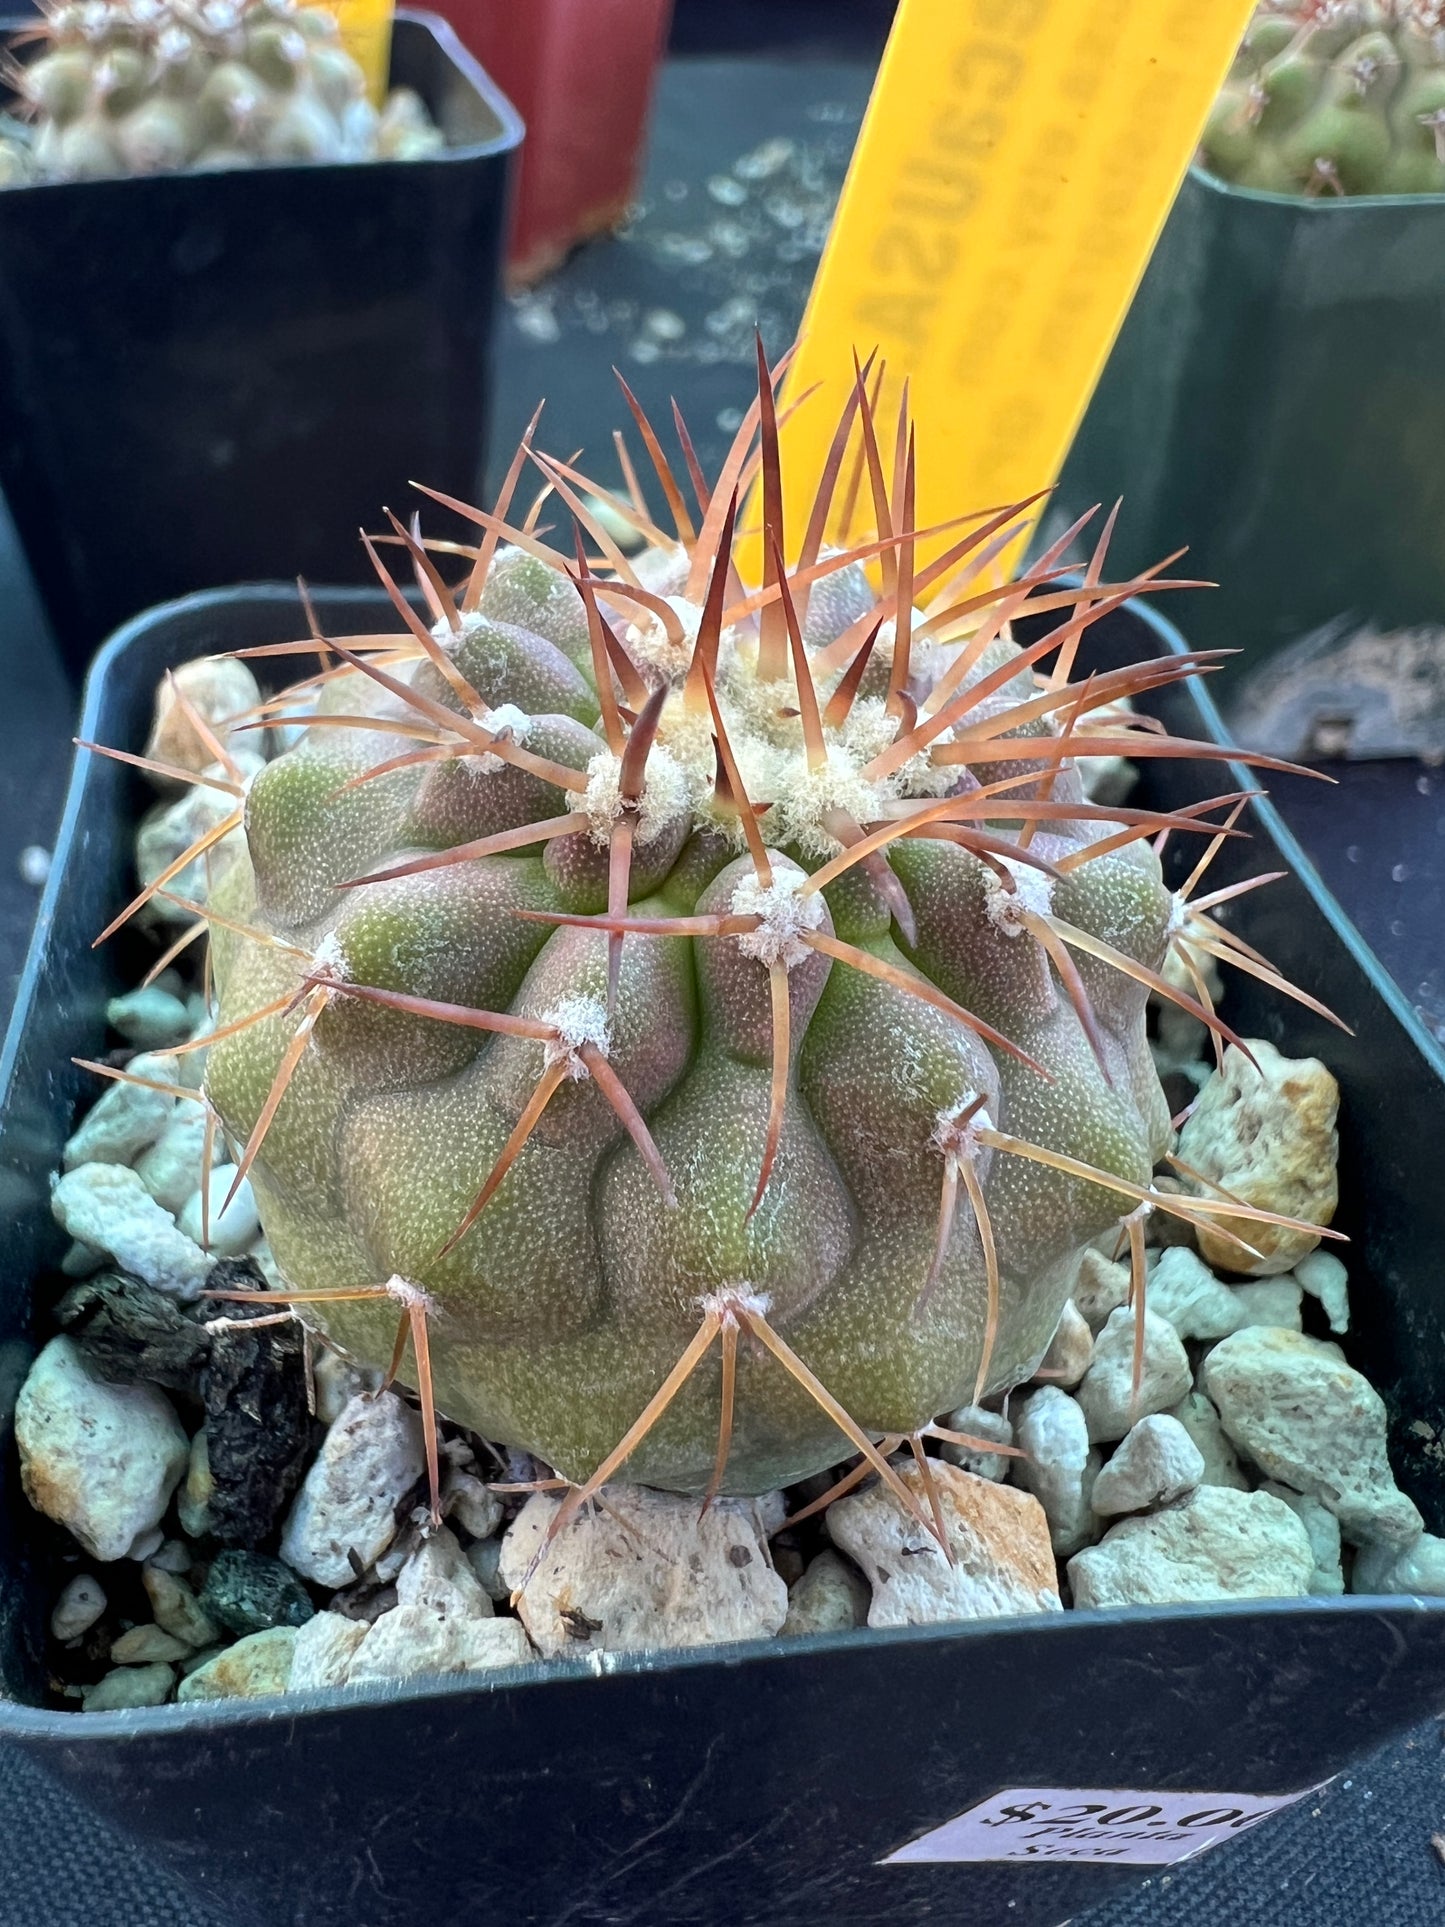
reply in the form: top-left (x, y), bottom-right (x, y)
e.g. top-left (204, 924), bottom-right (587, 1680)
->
top-left (782, 0), bottom-right (1254, 566)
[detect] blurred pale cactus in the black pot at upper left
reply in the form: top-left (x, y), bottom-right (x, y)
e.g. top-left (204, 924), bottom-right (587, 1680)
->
top-left (0, 0), bottom-right (441, 181)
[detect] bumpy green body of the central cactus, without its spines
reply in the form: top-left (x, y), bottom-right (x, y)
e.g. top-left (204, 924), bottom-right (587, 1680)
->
top-left (206, 504), bottom-right (1175, 1493)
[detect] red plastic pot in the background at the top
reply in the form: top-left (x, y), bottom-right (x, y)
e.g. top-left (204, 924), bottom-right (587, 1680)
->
top-left (435, 0), bottom-right (672, 283)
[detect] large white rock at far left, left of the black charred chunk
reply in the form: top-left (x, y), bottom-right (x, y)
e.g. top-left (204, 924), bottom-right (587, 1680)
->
top-left (15, 1337), bottom-right (187, 1559)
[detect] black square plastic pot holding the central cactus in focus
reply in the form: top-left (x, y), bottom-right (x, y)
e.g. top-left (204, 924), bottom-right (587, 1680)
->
top-left (0, 586), bottom-right (1445, 1927)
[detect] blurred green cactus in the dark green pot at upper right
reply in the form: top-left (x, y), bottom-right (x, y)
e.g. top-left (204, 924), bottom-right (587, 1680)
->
top-left (1202, 0), bottom-right (1445, 195)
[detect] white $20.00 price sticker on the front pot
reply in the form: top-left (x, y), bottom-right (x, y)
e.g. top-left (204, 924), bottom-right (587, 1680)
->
top-left (879, 1781), bottom-right (1329, 1867)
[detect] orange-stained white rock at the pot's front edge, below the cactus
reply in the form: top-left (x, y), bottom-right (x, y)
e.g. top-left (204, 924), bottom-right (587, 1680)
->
top-left (827, 1459), bottom-right (1062, 1626)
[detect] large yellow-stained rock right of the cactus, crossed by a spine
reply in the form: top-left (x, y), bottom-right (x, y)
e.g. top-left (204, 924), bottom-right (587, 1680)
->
top-left (1179, 1037), bottom-right (1339, 1278)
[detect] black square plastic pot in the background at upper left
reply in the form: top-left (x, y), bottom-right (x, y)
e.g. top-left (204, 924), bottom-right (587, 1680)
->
top-left (0, 13), bottom-right (522, 669)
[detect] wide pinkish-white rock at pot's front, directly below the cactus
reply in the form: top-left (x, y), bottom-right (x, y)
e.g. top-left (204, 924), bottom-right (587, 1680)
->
top-left (501, 1486), bottom-right (788, 1657)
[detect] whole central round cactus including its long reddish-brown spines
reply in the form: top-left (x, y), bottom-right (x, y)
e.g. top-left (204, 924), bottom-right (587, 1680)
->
top-left (87, 349), bottom-right (1333, 1518)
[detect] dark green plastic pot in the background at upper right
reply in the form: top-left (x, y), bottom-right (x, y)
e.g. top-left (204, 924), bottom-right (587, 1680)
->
top-left (1050, 168), bottom-right (1445, 732)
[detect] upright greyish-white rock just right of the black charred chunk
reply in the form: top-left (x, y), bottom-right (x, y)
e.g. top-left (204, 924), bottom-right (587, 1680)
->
top-left (281, 1391), bottom-right (426, 1586)
